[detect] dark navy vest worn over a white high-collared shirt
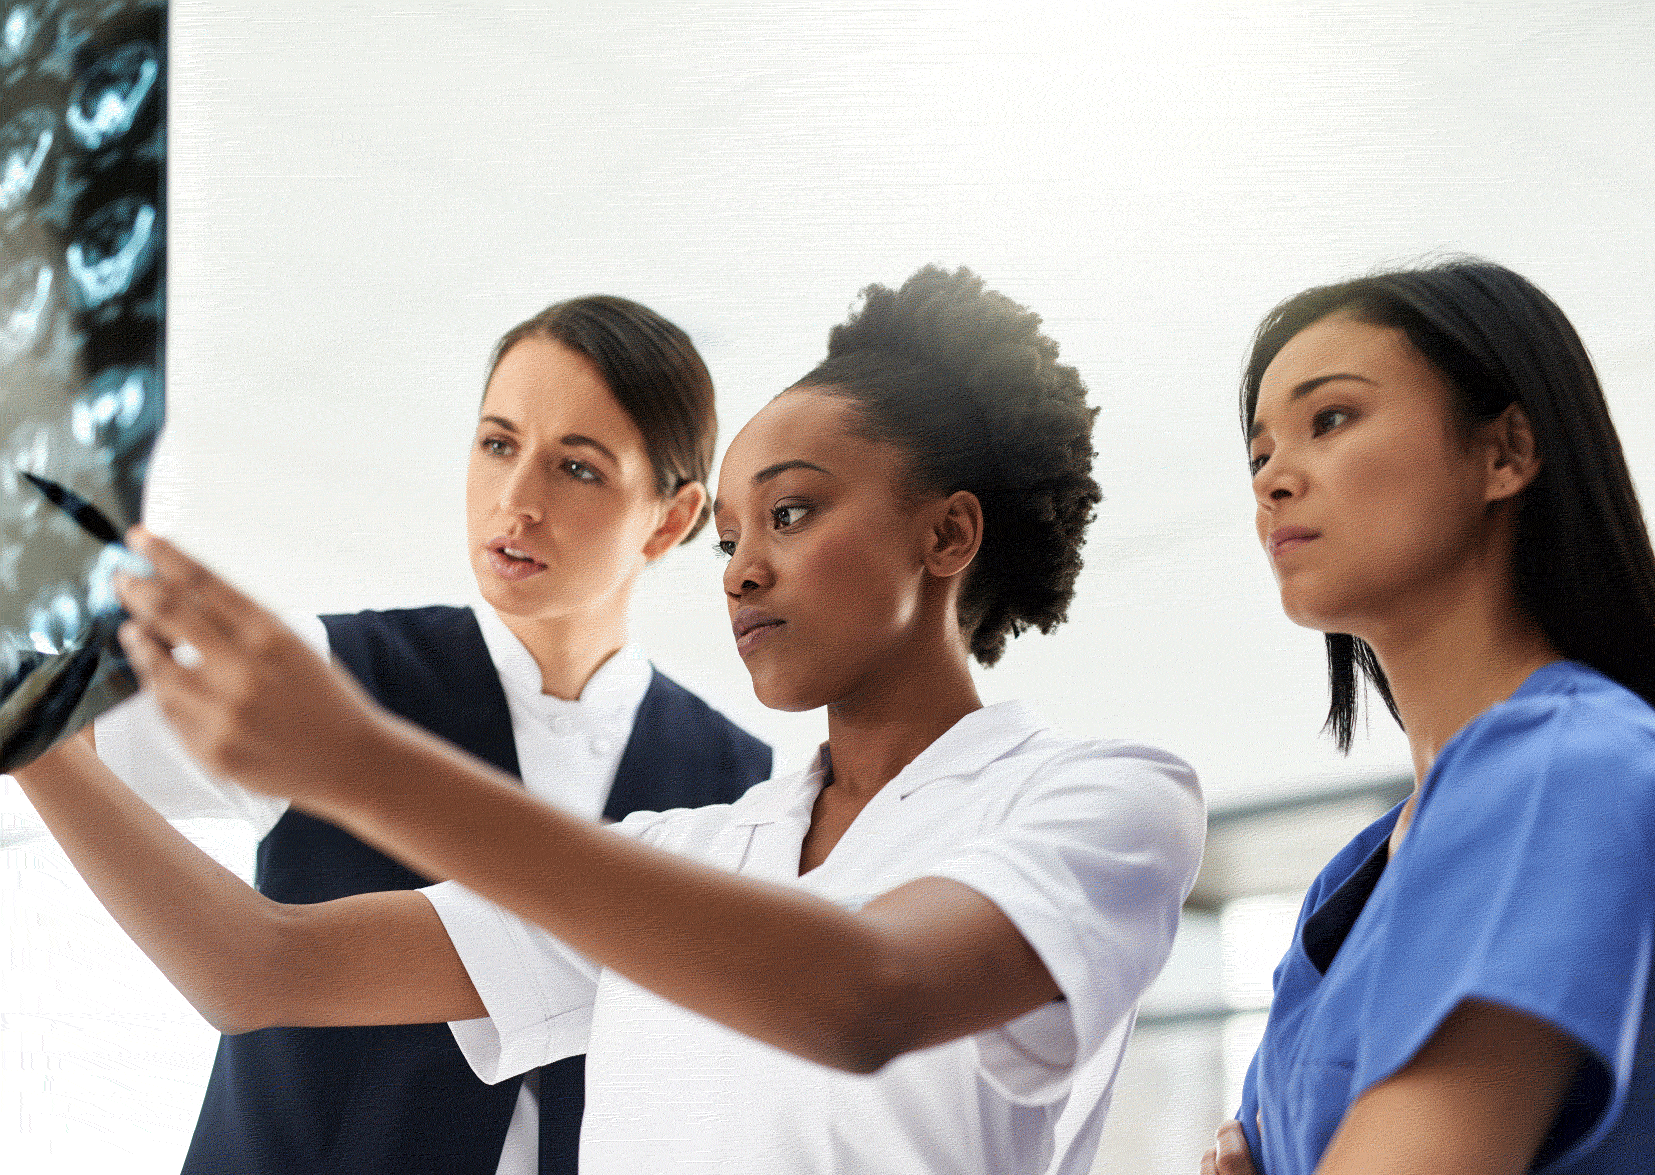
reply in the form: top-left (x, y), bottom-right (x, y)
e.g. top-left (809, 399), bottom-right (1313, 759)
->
top-left (184, 606), bottom-right (771, 1175)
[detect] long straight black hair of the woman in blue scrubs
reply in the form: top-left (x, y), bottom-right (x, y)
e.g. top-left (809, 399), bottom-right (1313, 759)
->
top-left (1241, 258), bottom-right (1655, 751)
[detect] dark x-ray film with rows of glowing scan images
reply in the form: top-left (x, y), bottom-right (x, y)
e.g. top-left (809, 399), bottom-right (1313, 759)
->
top-left (0, 0), bottom-right (167, 770)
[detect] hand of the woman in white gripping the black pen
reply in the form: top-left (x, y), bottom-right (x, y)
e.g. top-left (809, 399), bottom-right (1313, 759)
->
top-left (116, 526), bottom-right (386, 799)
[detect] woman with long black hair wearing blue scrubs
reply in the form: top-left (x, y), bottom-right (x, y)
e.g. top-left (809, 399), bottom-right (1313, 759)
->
top-left (1203, 260), bottom-right (1655, 1175)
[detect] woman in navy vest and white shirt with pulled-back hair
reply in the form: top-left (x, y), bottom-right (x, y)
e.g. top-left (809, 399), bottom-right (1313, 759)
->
top-left (85, 296), bottom-right (771, 1175)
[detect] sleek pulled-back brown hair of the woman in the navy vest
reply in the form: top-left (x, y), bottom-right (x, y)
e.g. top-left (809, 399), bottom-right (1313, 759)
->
top-left (488, 295), bottom-right (718, 543)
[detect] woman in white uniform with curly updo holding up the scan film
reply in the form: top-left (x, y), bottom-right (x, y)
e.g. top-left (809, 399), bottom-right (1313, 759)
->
top-left (12, 268), bottom-right (1203, 1175)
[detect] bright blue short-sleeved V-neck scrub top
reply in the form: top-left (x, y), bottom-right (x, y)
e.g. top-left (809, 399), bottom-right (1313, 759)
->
top-left (1236, 662), bottom-right (1655, 1175)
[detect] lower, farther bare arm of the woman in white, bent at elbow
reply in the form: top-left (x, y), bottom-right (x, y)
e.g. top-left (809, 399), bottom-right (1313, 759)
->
top-left (15, 736), bottom-right (483, 1033)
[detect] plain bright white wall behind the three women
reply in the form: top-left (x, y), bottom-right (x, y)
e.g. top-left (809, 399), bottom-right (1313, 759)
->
top-left (0, 0), bottom-right (1655, 1172)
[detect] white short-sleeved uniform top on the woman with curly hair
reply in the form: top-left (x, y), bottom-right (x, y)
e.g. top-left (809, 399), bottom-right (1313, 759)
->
top-left (422, 702), bottom-right (1203, 1175)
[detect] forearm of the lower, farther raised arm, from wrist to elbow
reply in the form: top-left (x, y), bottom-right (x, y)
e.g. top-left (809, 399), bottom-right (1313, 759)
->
top-left (15, 736), bottom-right (294, 1031)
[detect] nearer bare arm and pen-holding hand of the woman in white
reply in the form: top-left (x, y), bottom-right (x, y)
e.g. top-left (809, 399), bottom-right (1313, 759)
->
top-left (122, 533), bottom-right (1058, 1072)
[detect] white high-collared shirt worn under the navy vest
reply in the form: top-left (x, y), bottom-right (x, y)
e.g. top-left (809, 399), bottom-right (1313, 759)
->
top-left (96, 604), bottom-right (654, 1175)
